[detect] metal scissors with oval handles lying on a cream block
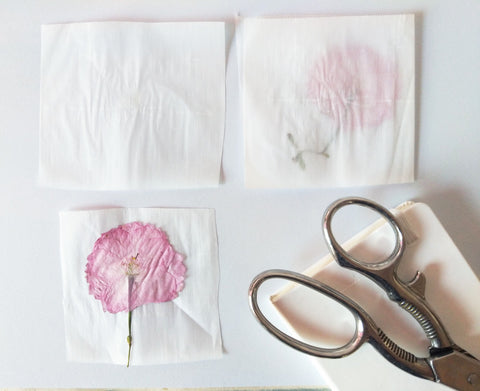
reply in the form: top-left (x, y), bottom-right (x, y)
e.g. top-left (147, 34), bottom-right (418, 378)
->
top-left (248, 197), bottom-right (480, 391)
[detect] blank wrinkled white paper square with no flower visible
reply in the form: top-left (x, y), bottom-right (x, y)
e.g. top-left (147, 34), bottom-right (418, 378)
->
top-left (39, 22), bottom-right (225, 190)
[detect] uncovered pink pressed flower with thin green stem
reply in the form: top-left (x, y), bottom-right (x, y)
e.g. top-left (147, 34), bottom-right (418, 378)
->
top-left (86, 222), bottom-right (186, 367)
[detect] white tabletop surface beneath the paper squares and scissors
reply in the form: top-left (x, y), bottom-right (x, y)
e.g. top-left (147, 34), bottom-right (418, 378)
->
top-left (0, 0), bottom-right (480, 388)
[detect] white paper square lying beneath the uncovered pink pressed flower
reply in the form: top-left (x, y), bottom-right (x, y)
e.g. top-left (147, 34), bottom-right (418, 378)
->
top-left (60, 208), bottom-right (222, 365)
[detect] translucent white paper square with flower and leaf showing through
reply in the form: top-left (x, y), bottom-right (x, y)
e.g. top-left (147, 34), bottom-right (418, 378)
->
top-left (242, 15), bottom-right (415, 188)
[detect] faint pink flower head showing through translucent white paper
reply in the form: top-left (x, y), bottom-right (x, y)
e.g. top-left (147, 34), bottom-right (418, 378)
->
top-left (308, 45), bottom-right (397, 130)
